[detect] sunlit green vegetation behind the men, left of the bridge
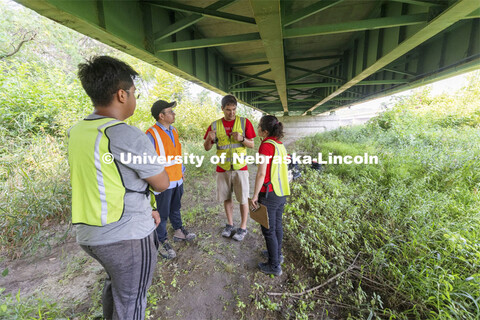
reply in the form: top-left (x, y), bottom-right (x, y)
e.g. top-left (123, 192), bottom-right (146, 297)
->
top-left (0, 1), bottom-right (219, 257)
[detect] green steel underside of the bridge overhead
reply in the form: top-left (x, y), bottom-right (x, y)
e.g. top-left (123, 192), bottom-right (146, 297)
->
top-left (16, 0), bottom-right (480, 115)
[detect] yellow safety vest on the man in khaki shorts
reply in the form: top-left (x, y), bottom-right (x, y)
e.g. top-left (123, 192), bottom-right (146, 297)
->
top-left (211, 117), bottom-right (247, 170)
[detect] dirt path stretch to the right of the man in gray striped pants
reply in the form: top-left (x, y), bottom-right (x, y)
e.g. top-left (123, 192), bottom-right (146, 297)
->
top-left (153, 167), bottom-right (287, 319)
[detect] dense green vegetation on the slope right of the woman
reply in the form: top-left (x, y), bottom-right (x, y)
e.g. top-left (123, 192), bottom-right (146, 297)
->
top-left (285, 73), bottom-right (480, 319)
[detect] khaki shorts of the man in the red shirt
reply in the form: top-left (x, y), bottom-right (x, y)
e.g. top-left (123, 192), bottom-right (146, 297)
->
top-left (217, 170), bottom-right (250, 204)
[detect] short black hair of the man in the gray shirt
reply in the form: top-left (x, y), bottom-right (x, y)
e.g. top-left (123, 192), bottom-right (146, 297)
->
top-left (78, 56), bottom-right (138, 107)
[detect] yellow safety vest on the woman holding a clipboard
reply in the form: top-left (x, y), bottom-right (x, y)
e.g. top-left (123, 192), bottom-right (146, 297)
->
top-left (264, 139), bottom-right (290, 196)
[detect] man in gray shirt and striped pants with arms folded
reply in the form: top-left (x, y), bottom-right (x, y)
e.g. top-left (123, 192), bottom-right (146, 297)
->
top-left (68, 56), bottom-right (170, 319)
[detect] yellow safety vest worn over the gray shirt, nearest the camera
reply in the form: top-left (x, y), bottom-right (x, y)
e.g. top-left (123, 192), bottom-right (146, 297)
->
top-left (68, 118), bottom-right (127, 226)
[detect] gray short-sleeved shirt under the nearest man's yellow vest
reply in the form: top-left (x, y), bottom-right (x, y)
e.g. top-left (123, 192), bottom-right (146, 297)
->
top-left (77, 114), bottom-right (164, 246)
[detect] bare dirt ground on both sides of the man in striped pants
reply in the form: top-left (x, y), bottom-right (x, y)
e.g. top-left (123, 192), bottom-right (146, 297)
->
top-left (0, 166), bottom-right (326, 319)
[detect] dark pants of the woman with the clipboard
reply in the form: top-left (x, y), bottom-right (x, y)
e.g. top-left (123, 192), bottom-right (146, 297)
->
top-left (258, 192), bottom-right (287, 268)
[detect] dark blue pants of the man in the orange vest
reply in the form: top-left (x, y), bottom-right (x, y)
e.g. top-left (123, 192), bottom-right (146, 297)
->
top-left (155, 184), bottom-right (183, 243)
